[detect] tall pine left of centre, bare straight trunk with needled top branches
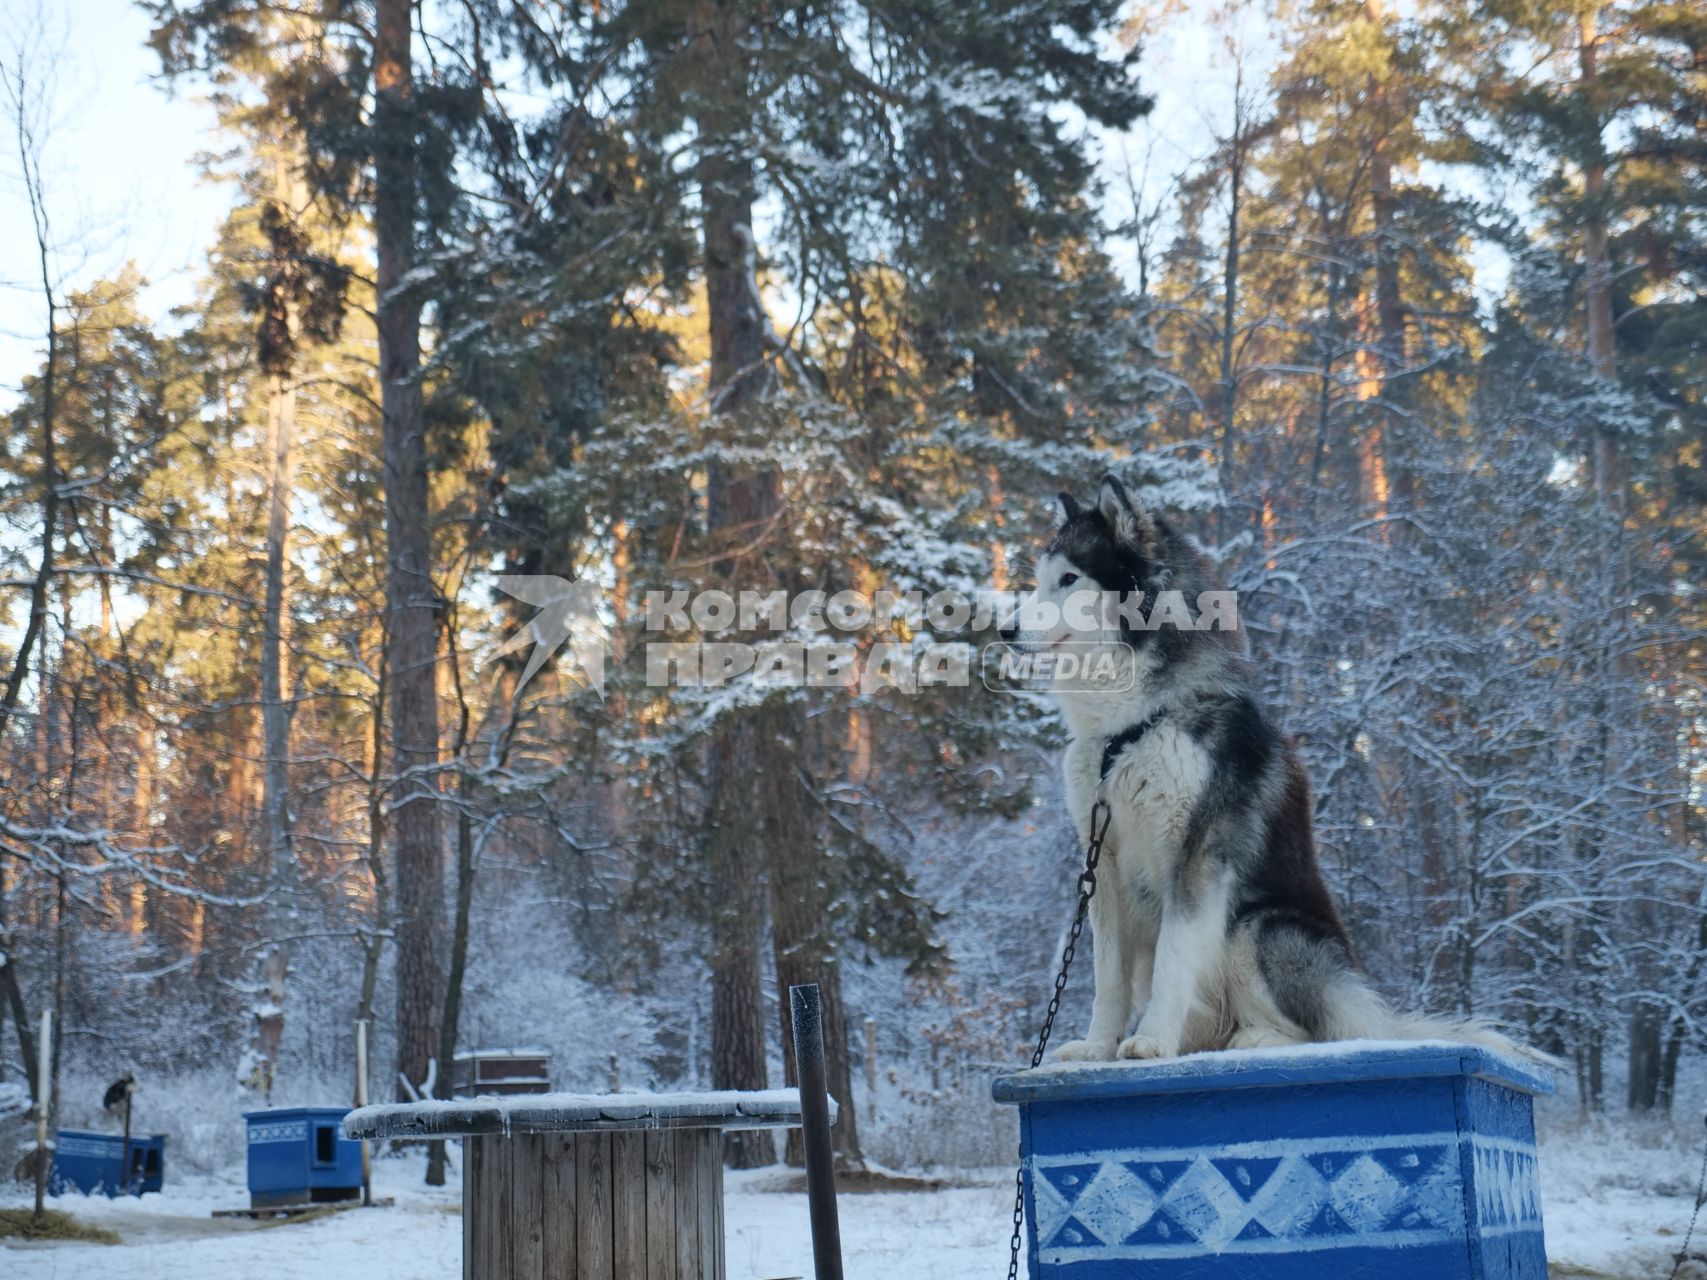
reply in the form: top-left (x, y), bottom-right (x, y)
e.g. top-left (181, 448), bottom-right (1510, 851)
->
top-left (150, 0), bottom-right (484, 1140)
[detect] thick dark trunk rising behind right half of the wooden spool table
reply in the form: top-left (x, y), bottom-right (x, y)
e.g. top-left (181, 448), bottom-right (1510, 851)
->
top-left (693, 0), bottom-right (778, 1167)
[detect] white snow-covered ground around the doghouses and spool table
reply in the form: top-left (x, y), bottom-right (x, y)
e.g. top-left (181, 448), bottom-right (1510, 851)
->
top-left (0, 1126), bottom-right (1707, 1280)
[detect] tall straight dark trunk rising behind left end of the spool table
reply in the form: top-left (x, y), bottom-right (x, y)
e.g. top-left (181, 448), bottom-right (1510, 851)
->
top-left (374, 0), bottom-right (449, 1153)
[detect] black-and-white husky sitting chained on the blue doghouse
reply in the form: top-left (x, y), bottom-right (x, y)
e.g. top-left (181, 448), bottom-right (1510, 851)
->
top-left (1000, 476), bottom-right (1511, 1060)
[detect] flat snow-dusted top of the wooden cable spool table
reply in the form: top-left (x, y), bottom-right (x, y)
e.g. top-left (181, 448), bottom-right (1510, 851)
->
top-left (343, 1089), bottom-right (836, 1138)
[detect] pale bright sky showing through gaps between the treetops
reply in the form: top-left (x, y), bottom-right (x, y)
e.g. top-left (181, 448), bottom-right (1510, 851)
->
top-left (0, 0), bottom-right (1263, 408)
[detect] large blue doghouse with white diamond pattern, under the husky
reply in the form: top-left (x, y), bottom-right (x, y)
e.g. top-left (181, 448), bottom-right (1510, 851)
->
top-left (993, 1041), bottom-right (1553, 1280)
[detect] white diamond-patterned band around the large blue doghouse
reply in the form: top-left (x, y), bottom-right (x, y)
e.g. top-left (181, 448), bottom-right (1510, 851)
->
top-left (1034, 1133), bottom-right (1508, 1263)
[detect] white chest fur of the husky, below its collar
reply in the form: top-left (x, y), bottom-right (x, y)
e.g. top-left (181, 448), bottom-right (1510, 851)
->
top-left (1063, 720), bottom-right (1212, 894)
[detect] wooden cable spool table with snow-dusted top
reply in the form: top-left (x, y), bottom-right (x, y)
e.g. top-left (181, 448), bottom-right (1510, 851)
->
top-left (343, 1089), bottom-right (833, 1280)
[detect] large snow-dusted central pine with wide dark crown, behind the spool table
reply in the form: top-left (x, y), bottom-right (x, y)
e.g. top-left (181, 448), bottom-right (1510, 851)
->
top-left (404, 3), bottom-right (1152, 1161)
